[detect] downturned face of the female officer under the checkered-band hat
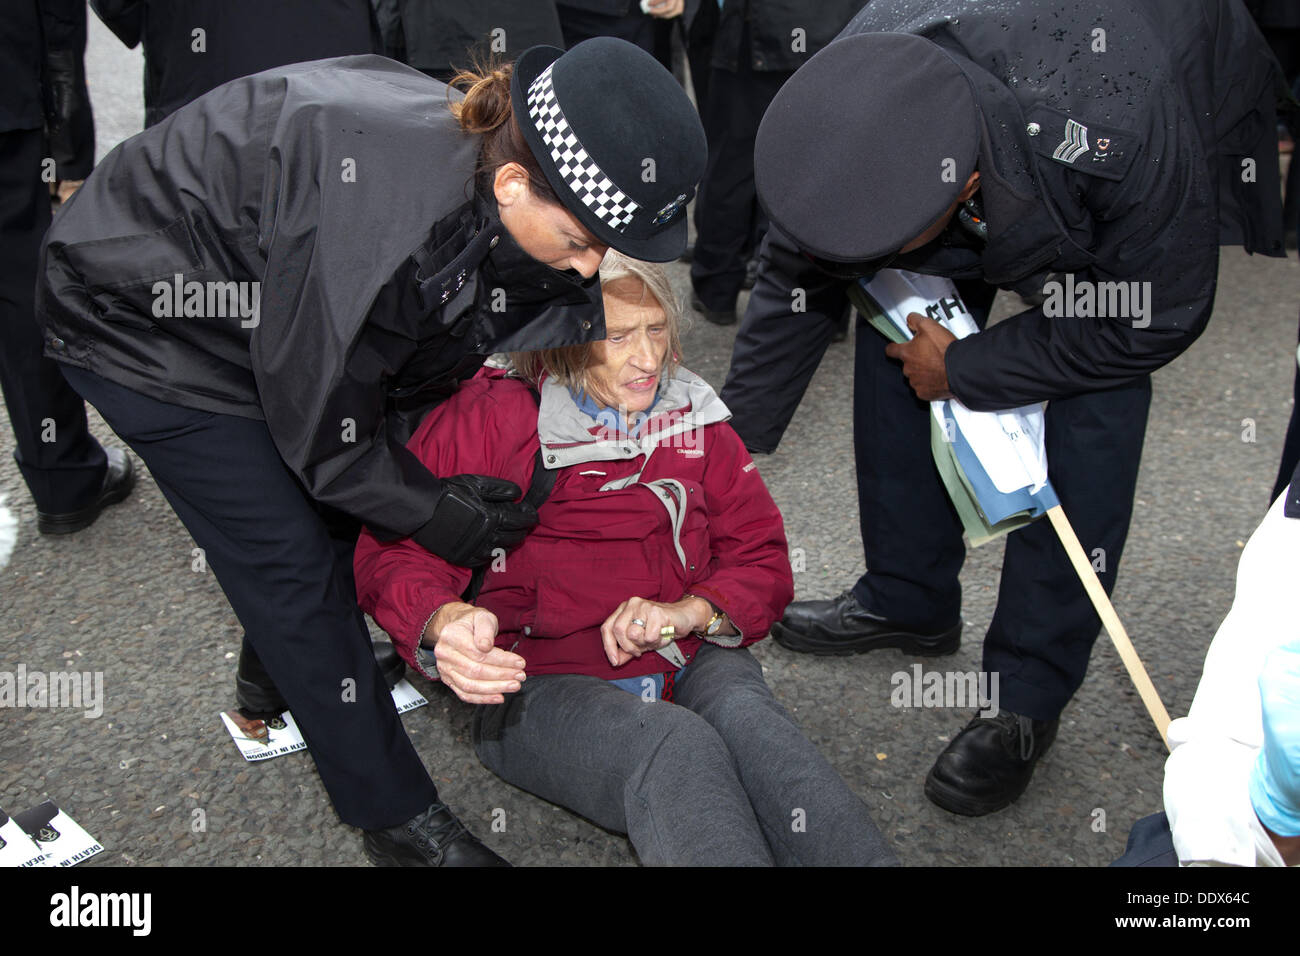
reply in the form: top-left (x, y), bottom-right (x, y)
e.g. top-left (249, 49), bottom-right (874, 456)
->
top-left (494, 163), bottom-right (608, 278)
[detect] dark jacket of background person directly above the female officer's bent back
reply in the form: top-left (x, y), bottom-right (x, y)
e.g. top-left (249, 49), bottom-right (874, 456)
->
top-left (90, 0), bottom-right (382, 126)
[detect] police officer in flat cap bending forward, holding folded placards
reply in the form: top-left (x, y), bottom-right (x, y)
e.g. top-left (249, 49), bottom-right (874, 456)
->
top-left (723, 0), bottom-right (1283, 816)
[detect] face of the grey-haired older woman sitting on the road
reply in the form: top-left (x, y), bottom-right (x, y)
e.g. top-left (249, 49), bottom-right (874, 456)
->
top-left (586, 277), bottom-right (668, 415)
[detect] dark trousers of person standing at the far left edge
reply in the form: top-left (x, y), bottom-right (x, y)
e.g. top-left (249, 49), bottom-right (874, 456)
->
top-left (0, 130), bottom-right (108, 514)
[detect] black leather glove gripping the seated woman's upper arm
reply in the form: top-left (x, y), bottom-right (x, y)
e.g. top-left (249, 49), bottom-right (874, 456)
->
top-left (411, 475), bottom-right (537, 567)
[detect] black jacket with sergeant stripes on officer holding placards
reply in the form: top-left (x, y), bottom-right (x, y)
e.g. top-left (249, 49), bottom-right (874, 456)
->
top-left (723, 0), bottom-right (1283, 451)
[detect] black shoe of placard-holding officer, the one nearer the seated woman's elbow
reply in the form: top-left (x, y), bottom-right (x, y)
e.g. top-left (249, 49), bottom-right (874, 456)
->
top-left (772, 591), bottom-right (962, 657)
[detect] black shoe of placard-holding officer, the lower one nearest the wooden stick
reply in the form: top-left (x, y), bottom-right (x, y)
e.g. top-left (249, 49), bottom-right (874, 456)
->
top-left (926, 710), bottom-right (1061, 817)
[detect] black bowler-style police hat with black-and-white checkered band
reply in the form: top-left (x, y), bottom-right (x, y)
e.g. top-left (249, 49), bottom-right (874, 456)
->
top-left (511, 36), bottom-right (707, 263)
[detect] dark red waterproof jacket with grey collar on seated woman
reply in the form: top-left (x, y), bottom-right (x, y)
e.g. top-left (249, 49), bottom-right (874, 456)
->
top-left (355, 369), bottom-right (794, 679)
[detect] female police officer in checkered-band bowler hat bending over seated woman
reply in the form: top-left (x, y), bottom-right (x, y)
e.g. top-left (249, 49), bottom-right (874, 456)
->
top-left (38, 39), bottom-right (705, 865)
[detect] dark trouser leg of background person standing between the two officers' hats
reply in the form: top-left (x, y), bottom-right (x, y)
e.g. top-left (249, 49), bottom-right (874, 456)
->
top-left (690, 51), bottom-right (792, 312)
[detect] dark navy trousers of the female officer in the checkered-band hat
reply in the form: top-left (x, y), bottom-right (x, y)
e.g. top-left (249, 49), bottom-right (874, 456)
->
top-left (65, 367), bottom-right (438, 830)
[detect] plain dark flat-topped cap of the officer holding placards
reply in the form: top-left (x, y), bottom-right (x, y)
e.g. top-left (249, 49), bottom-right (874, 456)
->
top-left (754, 34), bottom-right (982, 263)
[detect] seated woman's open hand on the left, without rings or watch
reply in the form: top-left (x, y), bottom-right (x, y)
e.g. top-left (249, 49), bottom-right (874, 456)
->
top-left (420, 601), bottom-right (527, 704)
